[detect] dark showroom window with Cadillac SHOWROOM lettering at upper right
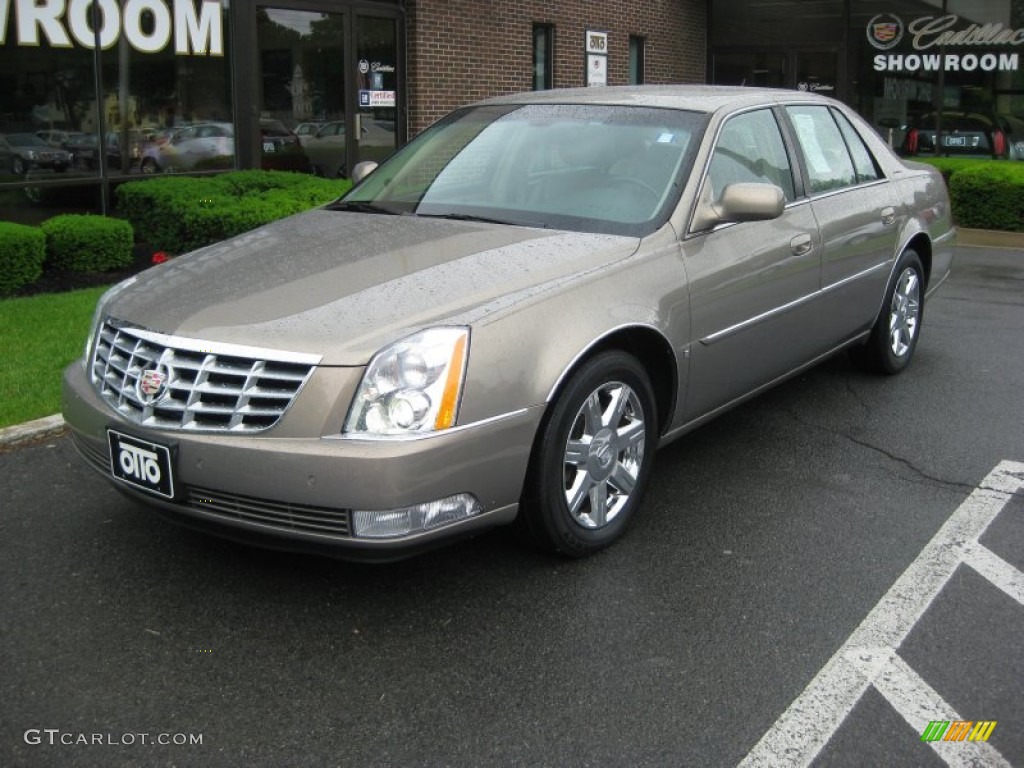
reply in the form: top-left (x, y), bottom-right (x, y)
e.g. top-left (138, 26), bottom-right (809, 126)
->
top-left (849, 0), bottom-right (1024, 160)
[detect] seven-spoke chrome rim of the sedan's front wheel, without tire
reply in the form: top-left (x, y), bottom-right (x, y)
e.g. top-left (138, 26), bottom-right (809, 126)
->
top-left (563, 381), bottom-right (646, 529)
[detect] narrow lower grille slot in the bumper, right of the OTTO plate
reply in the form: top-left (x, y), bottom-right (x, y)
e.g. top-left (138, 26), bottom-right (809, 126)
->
top-left (185, 487), bottom-right (350, 537)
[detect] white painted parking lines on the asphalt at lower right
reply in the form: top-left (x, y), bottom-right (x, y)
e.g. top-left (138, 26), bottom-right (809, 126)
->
top-left (740, 462), bottom-right (1024, 768)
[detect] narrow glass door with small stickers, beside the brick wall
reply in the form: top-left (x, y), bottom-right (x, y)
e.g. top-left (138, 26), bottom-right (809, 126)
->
top-left (352, 16), bottom-right (399, 168)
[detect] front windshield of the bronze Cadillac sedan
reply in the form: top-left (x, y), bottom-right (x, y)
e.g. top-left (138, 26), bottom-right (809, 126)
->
top-left (333, 104), bottom-right (707, 237)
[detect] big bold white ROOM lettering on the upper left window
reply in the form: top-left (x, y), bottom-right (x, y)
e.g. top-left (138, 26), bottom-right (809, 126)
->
top-left (0, 0), bottom-right (224, 56)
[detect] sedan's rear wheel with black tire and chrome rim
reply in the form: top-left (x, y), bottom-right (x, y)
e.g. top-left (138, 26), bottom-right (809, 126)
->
top-left (851, 249), bottom-right (925, 374)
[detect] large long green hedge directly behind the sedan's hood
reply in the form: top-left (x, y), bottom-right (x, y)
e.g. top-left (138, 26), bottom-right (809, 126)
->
top-left (117, 171), bottom-right (351, 254)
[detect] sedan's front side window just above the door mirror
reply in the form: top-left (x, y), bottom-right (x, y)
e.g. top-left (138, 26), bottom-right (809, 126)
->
top-left (708, 110), bottom-right (796, 202)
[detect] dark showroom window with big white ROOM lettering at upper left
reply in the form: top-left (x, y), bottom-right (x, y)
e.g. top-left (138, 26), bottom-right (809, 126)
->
top-left (0, 0), bottom-right (234, 219)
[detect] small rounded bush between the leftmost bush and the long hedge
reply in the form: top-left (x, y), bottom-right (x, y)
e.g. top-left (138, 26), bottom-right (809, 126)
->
top-left (42, 213), bottom-right (134, 272)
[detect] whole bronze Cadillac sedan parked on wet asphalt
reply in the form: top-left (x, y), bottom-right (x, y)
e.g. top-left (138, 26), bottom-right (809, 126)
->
top-left (63, 86), bottom-right (953, 560)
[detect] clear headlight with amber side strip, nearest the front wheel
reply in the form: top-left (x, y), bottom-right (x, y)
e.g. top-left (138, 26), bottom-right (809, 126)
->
top-left (345, 328), bottom-right (469, 435)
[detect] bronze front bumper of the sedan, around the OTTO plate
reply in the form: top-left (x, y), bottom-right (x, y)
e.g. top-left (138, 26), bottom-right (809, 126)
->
top-left (63, 362), bottom-right (543, 560)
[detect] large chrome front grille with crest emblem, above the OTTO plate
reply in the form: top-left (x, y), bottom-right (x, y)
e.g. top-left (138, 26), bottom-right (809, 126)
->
top-left (91, 321), bottom-right (321, 432)
